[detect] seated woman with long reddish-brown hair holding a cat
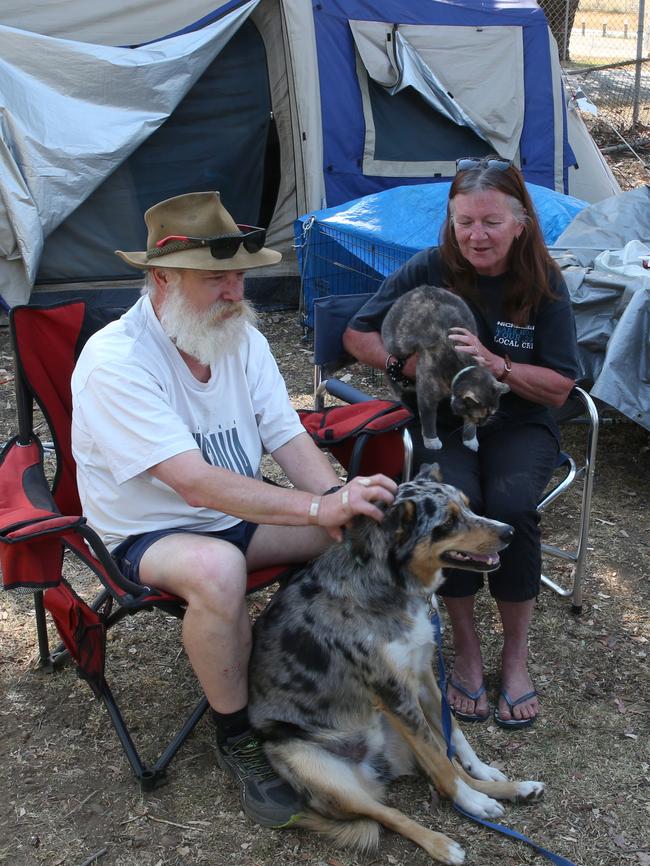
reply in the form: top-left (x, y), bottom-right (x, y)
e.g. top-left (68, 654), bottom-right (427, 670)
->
top-left (344, 157), bottom-right (578, 728)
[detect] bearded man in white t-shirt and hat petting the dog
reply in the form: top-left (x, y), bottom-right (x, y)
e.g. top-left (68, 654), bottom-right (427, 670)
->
top-left (72, 192), bottom-right (396, 827)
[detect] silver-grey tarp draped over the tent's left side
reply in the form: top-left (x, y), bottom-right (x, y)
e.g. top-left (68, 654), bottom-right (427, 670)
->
top-left (0, 0), bottom-right (259, 305)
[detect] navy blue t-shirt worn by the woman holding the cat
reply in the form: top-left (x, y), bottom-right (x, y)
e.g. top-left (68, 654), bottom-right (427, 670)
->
top-left (349, 247), bottom-right (579, 420)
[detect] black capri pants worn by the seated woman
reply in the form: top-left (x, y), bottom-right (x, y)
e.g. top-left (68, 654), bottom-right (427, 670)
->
top-left (411, 414), bottom-right (559, 601)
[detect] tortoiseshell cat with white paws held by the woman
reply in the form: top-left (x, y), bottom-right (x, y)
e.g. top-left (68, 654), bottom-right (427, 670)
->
top-left (381, 286), bottom-right (510, 451)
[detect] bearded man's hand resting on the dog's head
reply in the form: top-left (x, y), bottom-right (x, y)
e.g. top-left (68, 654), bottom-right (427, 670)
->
top-left (315, 473), bottom-right (397, 541)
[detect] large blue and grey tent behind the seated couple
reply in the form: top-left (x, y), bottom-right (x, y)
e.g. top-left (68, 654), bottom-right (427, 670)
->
top-left (0, 0), bottom-right (619, 305)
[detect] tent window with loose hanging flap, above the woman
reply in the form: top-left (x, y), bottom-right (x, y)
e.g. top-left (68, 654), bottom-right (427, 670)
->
top-left (349, 21), bottom-right (524, 177)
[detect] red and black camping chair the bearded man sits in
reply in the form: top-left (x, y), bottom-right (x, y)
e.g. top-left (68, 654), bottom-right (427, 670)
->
top-left (0, 301), bottom-right (411, 790)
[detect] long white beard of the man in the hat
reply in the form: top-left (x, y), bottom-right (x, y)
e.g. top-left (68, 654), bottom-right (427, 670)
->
top-left (159, 287), bottom-right (257, 366)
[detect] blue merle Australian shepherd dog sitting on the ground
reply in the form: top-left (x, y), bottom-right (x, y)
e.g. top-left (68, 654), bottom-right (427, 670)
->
top-left (250, 467), bottom-right (543, 864)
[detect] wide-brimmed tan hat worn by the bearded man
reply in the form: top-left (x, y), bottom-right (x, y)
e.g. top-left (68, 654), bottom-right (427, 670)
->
top-left (115, 192), bottom-right (282, 271)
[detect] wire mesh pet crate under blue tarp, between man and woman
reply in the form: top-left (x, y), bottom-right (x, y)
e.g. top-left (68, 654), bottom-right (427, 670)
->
top-left (296, 216), bottom-right (417, 329)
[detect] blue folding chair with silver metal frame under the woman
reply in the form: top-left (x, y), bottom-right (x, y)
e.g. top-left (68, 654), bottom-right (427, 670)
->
top-left (313, 294), bottom-right (599, 614)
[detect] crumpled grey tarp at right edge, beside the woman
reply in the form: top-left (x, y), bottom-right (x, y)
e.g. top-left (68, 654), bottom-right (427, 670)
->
top-left (551, 186), bottom-right (650, 430)
